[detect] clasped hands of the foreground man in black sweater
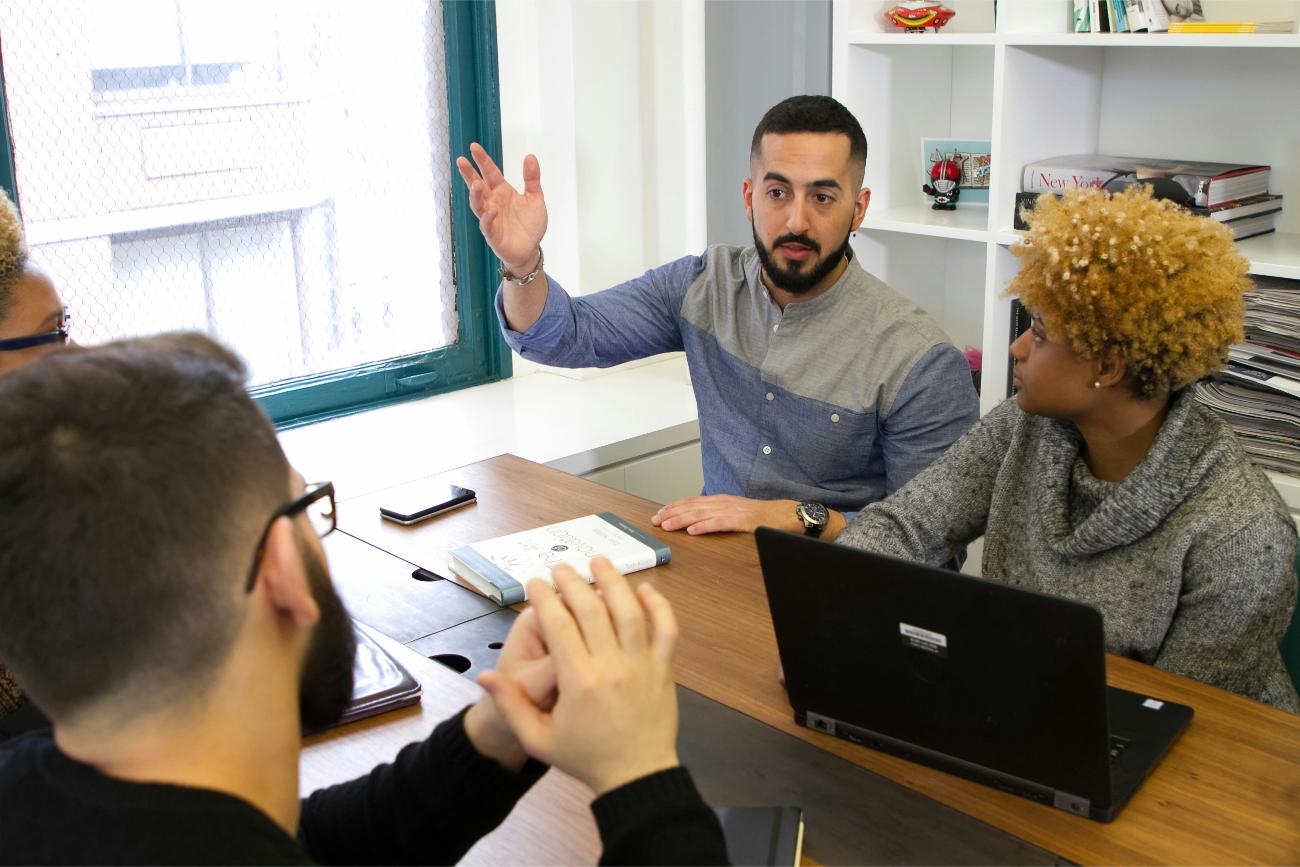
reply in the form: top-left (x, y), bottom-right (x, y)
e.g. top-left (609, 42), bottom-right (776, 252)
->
top-left (464, 558), bottom-right (679, 796)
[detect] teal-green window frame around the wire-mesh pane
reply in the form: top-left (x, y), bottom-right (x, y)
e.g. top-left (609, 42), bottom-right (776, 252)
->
top-left (0, 0), bottom-right (511, 430)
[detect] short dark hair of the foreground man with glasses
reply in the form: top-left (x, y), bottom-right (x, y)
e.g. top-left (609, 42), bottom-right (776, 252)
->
top-left (0, 334), bottom-right (290, 721)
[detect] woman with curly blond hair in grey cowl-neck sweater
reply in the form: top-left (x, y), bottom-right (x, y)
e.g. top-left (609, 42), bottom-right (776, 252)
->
top-left (836, 186), bottom-right (1300, 712)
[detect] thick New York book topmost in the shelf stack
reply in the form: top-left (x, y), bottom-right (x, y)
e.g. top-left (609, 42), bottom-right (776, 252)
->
top-left (1021, 153), bottom-right (1269, 208)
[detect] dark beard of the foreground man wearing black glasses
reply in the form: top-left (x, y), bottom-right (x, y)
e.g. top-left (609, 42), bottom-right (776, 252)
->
top-left (295, 536), bottom-right (356, 733)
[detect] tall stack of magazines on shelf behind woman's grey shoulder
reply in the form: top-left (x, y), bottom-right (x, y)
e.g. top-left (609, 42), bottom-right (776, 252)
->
top-left (1195, 277), bottom-right (1300, 476)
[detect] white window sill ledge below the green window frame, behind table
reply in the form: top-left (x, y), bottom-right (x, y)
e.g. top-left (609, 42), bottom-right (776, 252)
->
top-left (280, 356), bottom-right (699, 499)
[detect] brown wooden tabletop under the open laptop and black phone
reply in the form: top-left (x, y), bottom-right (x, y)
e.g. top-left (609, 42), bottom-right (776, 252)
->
top-left (322, 456), bottom-right (1300, 864)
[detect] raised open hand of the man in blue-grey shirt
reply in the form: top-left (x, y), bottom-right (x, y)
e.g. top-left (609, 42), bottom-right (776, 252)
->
top-left (456, 143), bottom-right (546, 276)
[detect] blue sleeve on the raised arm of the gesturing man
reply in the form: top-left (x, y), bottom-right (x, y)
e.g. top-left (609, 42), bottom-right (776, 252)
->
top-left (497, 256), bottom-right (705, 368)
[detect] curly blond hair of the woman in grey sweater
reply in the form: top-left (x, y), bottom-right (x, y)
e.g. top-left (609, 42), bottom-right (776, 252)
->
top-left (1006, 185), bottom-right (1251, 399)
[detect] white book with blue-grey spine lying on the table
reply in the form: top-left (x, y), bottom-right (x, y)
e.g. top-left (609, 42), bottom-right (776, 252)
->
top-left (450, 512), bottom-right (671, 606)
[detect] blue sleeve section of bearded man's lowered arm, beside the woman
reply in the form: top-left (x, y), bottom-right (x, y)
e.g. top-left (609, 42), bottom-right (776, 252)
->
top-left (880, 343), bottom-right (979, 497)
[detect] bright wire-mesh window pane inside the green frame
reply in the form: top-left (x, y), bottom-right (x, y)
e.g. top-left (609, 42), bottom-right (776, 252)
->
top-left (0, 0), bottom-right (456, 383)
